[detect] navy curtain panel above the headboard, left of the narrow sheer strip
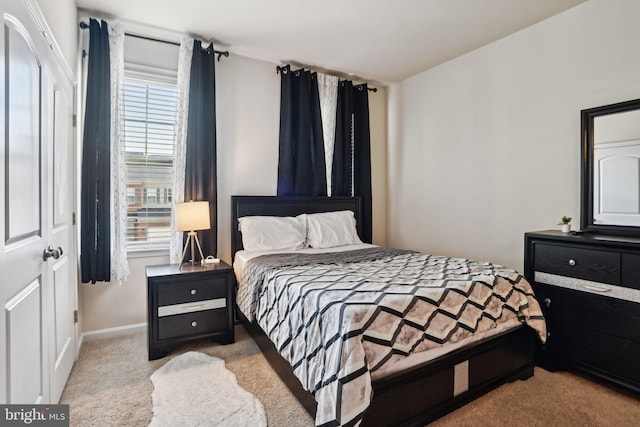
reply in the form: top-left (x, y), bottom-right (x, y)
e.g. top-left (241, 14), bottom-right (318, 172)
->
top-left (277, 66), bottom-right (327, 196)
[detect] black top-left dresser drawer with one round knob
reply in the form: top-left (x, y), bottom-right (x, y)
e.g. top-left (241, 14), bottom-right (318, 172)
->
top-left (535, 243), bottom-right (620, 285)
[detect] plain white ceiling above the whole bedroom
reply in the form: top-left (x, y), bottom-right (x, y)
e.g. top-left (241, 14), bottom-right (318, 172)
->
top-left (76, 0), bottom-right (585, 84)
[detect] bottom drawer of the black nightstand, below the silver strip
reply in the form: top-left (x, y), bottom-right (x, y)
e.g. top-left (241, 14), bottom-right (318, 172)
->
top-left (158, 309), bottom-right (228, 340)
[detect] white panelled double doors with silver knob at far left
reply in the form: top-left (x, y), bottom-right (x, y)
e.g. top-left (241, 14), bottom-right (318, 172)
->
top-left (0, 0), bottom-right (76, 404)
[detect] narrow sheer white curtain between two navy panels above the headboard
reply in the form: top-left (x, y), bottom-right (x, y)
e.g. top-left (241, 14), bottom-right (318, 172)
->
top-left (318, 73), bottom-right (338, 196)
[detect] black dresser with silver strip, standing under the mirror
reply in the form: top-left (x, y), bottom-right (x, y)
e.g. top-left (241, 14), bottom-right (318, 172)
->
top-left (524, 230), bottom-right (640, 392)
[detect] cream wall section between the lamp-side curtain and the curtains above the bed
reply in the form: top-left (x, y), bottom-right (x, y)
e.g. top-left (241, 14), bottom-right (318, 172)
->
top-left (216, 52), bottom-right (280, 262)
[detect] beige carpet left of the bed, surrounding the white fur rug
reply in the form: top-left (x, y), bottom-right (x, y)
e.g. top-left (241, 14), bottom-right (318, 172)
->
top-left (60, 327), bottom-right (313, 426)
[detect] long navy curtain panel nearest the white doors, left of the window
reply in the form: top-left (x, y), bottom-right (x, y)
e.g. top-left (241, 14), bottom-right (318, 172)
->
top-left (80, 19), bottom-right (111, 283)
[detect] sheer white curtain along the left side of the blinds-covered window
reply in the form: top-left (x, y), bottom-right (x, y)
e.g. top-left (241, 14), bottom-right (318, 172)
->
top-left (109, 23), bottom-right (129, 284)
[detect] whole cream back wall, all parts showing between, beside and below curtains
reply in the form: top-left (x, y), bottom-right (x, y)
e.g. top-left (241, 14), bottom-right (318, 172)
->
top-left (80, 48), bottom-right (387, 332)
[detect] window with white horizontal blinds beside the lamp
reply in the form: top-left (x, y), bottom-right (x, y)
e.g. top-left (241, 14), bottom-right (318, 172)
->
top-left (123, 76), bottom-right (176, 250)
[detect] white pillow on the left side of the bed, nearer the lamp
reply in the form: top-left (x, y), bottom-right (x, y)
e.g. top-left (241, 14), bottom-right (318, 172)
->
top-left (238, 215), bottom-right (307, 252)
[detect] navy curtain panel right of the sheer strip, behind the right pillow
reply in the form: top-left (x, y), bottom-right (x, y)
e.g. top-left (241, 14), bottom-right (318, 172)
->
top-left (331, 80), bottom-right (373, 243)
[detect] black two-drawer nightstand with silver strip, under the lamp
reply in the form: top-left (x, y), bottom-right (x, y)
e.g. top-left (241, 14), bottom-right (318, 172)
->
top-left (146, 261), bottom-right (234, 360)
